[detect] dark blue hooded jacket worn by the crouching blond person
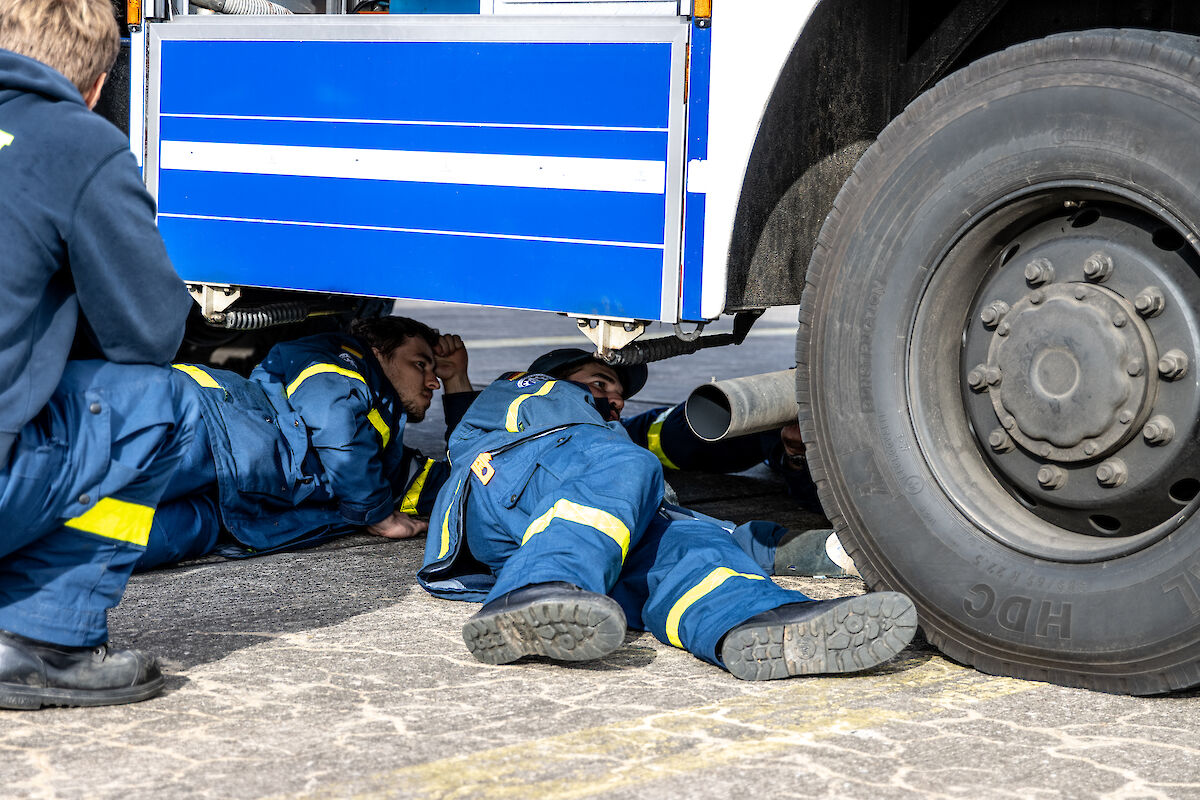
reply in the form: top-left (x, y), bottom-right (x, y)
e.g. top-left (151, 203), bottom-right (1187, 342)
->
top-left (0, 49), bottom-right (191, 465)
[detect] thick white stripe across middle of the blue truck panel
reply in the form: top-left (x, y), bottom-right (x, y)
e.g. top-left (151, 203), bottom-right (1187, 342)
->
top-left (160, 142), bottom-right (667, 194)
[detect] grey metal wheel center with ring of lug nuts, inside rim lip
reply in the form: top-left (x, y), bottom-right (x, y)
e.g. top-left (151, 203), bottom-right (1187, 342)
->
top-left (960, 204), bottom-right (1200, 537)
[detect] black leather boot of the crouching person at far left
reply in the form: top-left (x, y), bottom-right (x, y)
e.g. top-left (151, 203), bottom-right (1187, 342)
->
top-left (0, 631), bottom-right (163, 709)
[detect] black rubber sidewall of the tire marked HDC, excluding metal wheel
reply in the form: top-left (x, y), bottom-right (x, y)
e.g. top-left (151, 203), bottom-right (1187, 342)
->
top-left (810, 37), bottom-right (1200, 690)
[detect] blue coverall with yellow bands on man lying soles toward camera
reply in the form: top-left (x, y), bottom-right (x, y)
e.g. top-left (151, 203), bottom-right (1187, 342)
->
top-left (418, 373), bottom-right (808, 664)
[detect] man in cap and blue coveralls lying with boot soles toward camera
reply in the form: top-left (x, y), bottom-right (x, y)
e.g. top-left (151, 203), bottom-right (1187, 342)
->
top-left (418, 361), bottom-right (917, 680)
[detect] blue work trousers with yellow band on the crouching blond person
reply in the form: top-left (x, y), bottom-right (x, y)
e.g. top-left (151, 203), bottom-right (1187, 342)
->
top-left (0, 361), bottom-right (203, 646)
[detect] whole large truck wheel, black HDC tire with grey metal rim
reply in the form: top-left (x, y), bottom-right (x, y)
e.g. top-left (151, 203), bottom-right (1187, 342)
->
top-left (797, 30), bottom-right (1200, 694)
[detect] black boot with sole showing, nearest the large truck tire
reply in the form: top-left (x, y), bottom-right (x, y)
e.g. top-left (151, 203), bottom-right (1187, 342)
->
top-left (719, 591), bottom-right (917, 680)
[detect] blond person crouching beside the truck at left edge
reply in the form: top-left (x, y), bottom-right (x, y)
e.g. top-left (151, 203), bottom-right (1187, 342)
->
top-left (0, 0), bottom-right (198, 709)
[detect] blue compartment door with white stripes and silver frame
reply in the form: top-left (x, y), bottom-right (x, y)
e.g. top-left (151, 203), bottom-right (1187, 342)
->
top-left (146, 17), bottom-right (688, 321)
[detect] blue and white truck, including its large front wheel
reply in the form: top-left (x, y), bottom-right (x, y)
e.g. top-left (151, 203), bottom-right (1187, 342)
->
top-left (106, 0), bottom-right (1200, 694)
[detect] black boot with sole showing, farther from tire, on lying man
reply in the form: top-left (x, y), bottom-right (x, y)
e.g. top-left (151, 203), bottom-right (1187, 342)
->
top-left (462, 581), bottom-right (625, 664)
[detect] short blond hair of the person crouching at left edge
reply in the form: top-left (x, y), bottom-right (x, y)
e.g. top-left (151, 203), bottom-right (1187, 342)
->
top-left (0, 0), bottom-right (121, 94)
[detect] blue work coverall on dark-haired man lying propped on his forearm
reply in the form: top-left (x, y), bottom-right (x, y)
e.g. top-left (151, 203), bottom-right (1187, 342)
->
top-left (138, 333), bottom-right (449, 570)
